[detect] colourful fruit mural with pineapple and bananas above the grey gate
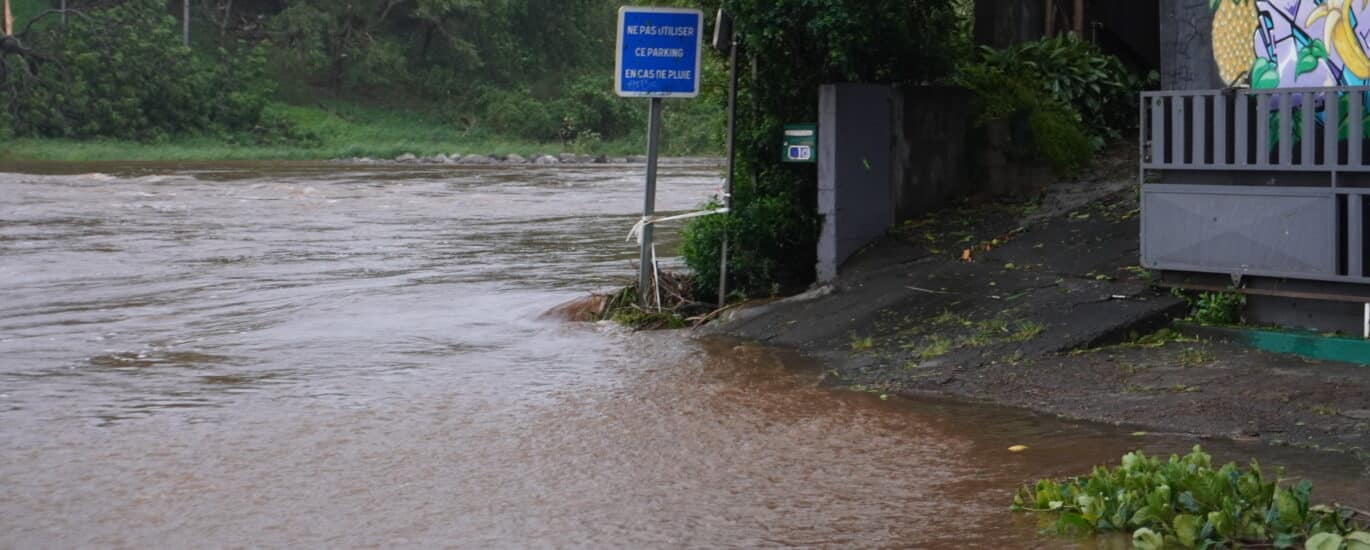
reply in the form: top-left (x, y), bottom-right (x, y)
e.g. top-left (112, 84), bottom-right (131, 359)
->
top-left (1210, 0), bottom-right (1370, 89)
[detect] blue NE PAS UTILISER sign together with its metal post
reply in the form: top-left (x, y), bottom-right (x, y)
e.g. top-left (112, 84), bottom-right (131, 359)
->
top-left (614, 7), bottom-right (704, 306)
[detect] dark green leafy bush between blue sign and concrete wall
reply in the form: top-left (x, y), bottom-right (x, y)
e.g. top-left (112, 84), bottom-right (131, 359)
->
top-left (681, 0), bottom-right (969, 296)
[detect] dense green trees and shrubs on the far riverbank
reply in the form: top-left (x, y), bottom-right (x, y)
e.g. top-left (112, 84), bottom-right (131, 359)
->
top-left (0, 0), bottom-right (722, 154)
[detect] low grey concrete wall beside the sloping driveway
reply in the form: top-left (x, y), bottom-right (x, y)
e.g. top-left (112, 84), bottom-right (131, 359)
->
top-left (818, 84), bottom-right (1044, 283)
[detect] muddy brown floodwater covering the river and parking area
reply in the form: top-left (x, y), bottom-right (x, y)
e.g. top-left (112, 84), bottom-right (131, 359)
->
top-left (0, 163), bottom-right (1370, 549)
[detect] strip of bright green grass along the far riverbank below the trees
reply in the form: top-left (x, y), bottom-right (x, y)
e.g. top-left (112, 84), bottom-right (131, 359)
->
top-left (0, 101), bottom-right (710, 162)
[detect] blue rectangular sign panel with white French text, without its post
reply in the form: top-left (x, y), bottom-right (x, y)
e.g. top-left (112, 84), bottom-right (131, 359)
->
top-left (614, 7), bottom-right (704, 97)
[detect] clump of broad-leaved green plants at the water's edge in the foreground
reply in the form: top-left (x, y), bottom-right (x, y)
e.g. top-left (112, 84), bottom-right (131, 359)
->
top-left (1012, 447), bottom-right (1370, 550)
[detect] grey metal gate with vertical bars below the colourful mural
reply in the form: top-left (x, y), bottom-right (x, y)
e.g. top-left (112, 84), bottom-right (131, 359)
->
top-left (1140, 86), bottom-right (1370, 284)
